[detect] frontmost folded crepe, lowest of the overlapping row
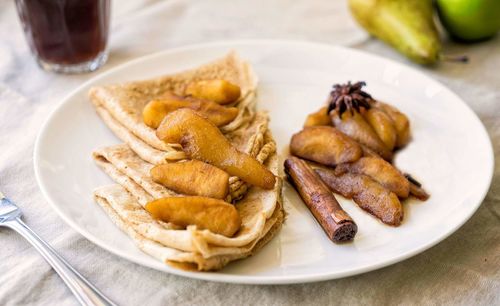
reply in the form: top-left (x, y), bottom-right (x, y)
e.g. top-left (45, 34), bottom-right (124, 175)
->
top-left (94, 185), bottom-right (284, 271)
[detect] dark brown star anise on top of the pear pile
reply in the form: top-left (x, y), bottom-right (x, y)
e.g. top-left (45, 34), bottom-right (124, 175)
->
top-left (327, 81), bottom-right (373, 116)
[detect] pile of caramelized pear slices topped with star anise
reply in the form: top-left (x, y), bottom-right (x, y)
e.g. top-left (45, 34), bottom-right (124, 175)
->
top-left (285, 82), bottom-right (429, 230)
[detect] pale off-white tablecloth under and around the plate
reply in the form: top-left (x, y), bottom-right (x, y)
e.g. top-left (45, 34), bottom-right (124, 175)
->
top-left (0, 0), bottom-right (500, 305)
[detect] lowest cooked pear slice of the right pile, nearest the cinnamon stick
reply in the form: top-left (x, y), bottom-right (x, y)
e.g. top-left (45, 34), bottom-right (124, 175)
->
top-left (315, 168), bottom-right (403, 226)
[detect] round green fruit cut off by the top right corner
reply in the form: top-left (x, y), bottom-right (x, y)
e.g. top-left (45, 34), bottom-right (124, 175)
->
top-left (436, 0), bottom-right (500, 41)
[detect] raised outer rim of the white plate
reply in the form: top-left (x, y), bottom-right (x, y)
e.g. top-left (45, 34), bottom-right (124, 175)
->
top-left (33, 39), bottom-right (495, 285)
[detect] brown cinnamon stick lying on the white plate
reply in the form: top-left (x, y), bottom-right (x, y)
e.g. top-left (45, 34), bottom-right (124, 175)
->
top-left (285, 156), bottom-right (358, 243)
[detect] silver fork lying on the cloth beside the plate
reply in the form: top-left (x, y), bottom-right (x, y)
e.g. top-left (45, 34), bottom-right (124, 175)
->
top-left (0, 192), bottom-right (115, 305)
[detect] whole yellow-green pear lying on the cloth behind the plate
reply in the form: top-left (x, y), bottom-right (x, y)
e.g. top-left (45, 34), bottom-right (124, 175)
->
top-left (349, 0), bottom-right (441, 65)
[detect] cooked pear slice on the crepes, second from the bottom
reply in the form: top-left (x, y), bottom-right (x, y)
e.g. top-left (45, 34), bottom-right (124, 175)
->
top-left (150, 160), bottom-right (229, 199)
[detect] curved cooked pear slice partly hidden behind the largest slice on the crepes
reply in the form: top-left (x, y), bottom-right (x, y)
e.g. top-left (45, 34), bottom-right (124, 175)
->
top-left (142, 94), bottom-right (238, 129)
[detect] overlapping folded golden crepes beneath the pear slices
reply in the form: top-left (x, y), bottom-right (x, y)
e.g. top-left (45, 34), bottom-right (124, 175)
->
top-left (90, 53), bottom-right (284, 270)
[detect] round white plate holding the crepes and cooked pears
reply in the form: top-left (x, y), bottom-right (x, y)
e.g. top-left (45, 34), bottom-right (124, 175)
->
top-left (34, 41), bottom-right (493, 284)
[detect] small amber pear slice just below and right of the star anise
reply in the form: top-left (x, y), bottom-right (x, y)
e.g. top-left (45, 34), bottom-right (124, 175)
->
top-left (363, 107), bottom-right (398, 151)
